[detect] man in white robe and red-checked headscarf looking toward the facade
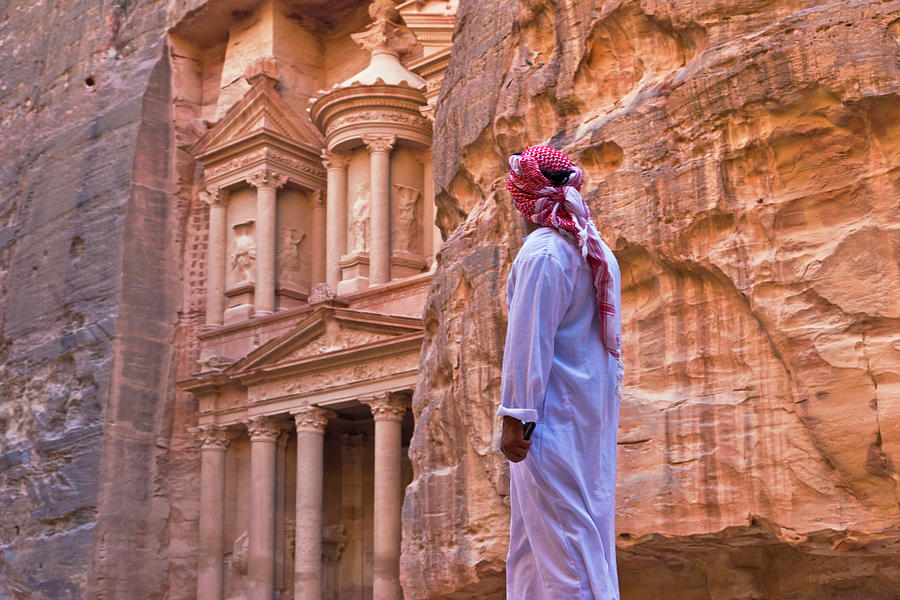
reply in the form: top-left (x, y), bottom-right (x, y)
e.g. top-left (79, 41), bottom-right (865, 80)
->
top-left (497, 146), bottom-right (622, 600)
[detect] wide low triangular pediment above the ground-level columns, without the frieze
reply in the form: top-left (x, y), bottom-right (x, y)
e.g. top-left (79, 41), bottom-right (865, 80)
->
top-left (227, 306), bottom-right (424, 375)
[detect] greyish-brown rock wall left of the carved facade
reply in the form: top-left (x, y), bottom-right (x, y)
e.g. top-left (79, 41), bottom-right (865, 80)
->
top-left (0, 0), bottom-right (199, 599)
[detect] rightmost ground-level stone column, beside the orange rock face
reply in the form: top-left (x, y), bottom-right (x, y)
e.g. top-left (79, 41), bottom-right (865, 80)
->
top-left (360, 393), bottom-right (407, 600)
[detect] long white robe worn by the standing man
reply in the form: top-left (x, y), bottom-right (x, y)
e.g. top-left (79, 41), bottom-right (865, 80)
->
top-left (498, 227), bottom-right (621, 600)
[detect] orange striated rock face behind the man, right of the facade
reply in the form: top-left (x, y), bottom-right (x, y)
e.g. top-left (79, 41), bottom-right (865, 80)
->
top-left (402, 0), bottom-right (900, 599)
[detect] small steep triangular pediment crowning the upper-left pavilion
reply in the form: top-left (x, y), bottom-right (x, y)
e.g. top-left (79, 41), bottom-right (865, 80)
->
top-left (191, 78), bottom-right (324, 157)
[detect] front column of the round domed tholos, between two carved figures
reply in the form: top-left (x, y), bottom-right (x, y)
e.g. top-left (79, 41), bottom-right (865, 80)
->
top-left (362, 135), bottom-right (397, 283)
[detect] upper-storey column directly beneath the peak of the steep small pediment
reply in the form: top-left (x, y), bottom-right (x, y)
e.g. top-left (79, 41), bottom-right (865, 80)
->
top-left (247, 169), bottom-right (287, 315)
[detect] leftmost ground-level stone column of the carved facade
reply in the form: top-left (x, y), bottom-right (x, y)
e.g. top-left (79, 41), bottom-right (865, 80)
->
top-left (194, 425), bottom-right (229, 600)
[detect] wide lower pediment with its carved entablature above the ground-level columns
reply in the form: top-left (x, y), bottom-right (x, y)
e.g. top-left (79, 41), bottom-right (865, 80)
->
top-left (179, 304), bottom-right (424, 424)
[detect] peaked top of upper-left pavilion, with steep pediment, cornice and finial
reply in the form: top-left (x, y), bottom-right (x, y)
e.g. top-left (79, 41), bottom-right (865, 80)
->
top-left (191, 56), bottom-right (325, 190)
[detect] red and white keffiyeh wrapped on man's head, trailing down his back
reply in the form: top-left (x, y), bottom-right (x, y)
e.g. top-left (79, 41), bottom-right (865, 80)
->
top-left (506, 146), bottom-right (622, 358)
